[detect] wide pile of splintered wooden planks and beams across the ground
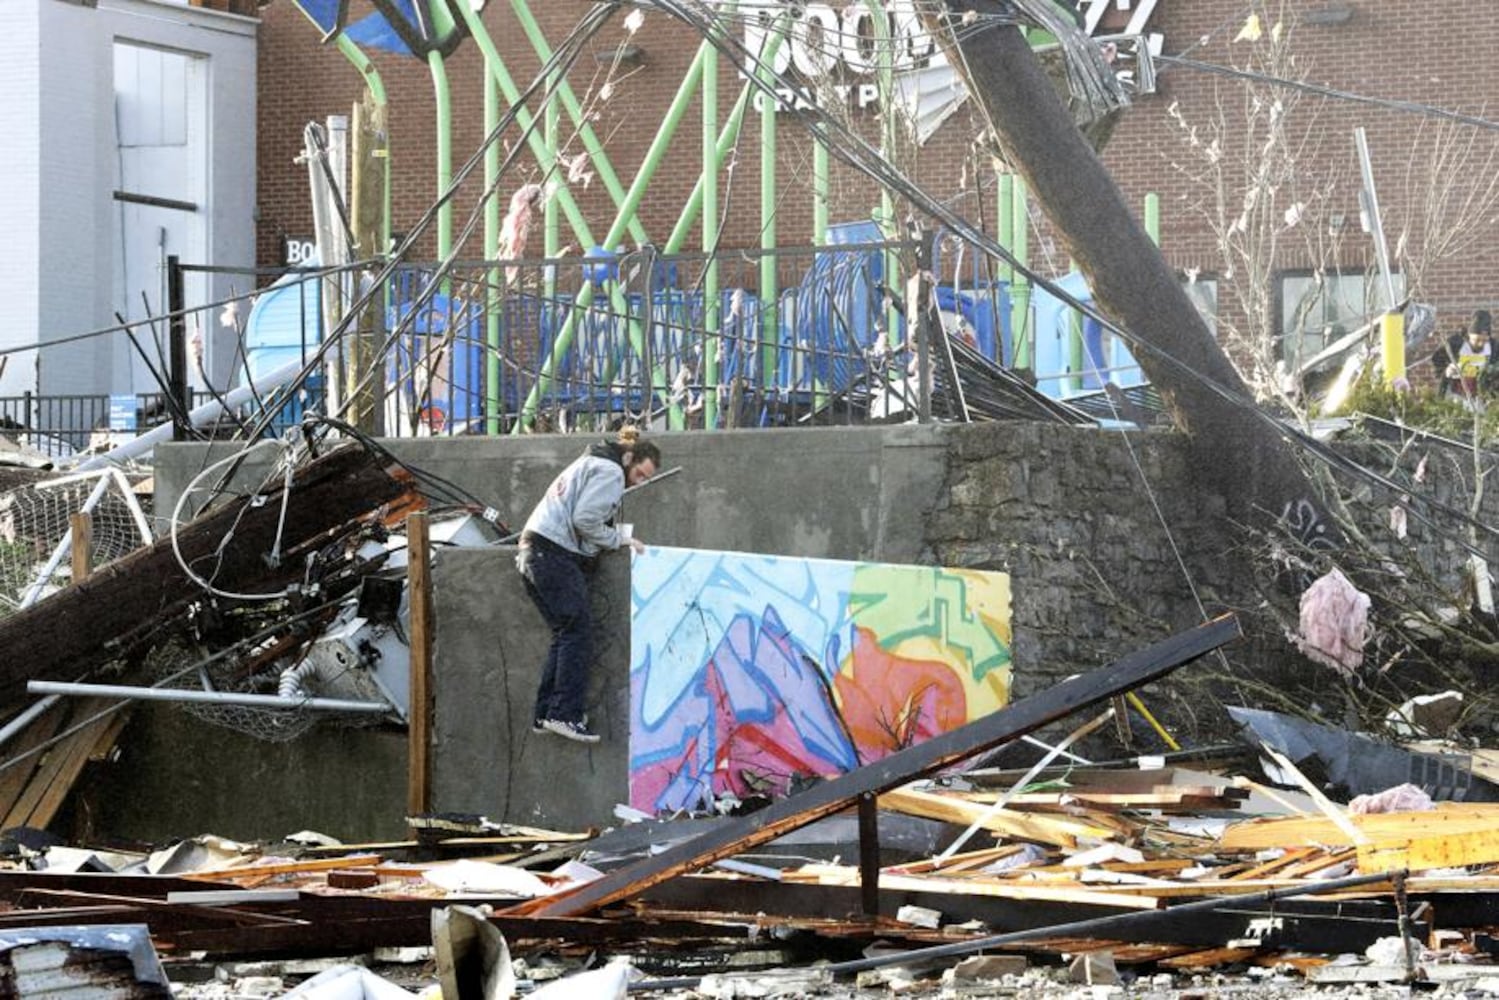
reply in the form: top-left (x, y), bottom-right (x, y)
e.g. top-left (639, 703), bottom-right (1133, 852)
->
top-left (0, 622), bottom-right (1499, 984)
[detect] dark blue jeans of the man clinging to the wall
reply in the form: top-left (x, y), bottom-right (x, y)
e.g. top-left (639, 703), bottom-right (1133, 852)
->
top-left (519, 538), bottom-right (592, 723)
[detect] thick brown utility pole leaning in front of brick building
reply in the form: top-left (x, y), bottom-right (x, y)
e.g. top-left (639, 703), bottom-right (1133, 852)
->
top-left (925, 0), bottom-right (1336, 544)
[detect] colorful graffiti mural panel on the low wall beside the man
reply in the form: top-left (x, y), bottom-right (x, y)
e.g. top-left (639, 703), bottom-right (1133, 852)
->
top-left (630, 547), bottom-right (1010, 813)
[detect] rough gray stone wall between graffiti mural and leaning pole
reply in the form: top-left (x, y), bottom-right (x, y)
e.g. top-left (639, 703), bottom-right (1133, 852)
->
top-left (925, 424), bottom-right (1244, 696)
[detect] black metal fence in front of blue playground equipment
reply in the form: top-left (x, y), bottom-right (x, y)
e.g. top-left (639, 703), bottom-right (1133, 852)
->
top-left (0, 241), bottom-right (995, 454)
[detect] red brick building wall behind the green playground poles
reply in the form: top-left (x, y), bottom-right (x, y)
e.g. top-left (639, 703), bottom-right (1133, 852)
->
top-left (258, 0), bottom-right (1499, 377)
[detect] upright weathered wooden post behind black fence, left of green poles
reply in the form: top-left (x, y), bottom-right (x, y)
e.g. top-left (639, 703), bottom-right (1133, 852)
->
top-left (343, 91), bottom-right (388, 435)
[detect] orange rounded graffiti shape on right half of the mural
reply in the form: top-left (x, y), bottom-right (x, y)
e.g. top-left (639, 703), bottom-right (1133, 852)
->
top-left (833, 628), bottom-right (968, 763)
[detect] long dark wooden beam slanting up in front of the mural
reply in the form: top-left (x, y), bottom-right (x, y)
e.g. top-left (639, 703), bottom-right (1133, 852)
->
top-left (532, 615), bottom-right (1240, 916)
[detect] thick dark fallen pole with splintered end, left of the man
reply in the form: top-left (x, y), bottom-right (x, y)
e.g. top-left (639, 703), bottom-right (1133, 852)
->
top-left (0, 445), bottom-right (411, 703)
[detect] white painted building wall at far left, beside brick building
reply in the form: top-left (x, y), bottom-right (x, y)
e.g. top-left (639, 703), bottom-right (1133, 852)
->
top-left (0, 0), bottom-right (256, 407)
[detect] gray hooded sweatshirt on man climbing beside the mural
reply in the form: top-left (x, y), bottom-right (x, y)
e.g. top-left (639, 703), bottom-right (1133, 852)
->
top-left (525, 442), bottom-right (628, 556)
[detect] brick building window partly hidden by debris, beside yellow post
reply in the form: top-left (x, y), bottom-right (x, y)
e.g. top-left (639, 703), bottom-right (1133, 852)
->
top-left (1276, 271), bottom-right (1405, 370)
